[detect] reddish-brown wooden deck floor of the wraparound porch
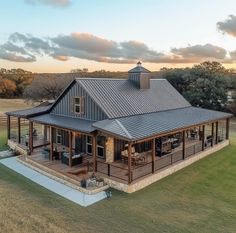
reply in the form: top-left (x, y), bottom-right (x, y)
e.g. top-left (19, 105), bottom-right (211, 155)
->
top-left (22, 139), bottom-right (205, 183)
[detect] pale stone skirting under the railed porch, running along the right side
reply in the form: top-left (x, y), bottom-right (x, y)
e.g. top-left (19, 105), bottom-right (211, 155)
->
top-left (104, 140), bottom-right (229, 193)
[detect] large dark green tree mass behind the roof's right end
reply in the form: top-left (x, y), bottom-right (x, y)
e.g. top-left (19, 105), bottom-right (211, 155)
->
top-left (161, 61), bottom-right (232, 110)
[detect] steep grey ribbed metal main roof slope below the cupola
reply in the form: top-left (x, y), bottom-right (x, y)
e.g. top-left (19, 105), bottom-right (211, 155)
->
top-left (76, 78), bottom-right (191, 118)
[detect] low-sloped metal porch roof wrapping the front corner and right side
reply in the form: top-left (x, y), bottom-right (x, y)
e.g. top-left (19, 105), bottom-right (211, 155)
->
top-left (93, 107), bottom-right (232, 141)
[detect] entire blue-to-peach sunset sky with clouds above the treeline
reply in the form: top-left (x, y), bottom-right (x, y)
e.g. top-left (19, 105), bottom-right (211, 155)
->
top-left (0, 0), bottom-right (236, 73)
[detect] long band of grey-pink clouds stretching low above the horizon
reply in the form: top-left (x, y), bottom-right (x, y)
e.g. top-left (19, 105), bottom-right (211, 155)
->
top-left (0, 32), bottom-right (230, 64)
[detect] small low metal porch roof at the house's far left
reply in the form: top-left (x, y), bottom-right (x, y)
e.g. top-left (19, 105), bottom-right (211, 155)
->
top-left (6, 104), bottom-right (52, 118)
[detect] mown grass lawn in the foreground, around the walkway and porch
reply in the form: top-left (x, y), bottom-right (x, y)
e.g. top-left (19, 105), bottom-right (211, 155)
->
top-left (0, 124), bottom-right (236, 233)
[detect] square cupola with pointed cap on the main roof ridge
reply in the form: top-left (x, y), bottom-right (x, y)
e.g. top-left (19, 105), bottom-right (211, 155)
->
top-left (128, 61), bottom-right (151, 89)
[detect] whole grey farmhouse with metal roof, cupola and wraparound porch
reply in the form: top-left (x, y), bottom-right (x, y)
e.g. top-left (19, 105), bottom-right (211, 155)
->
top-left (6, 63), bottom-right (232, 192)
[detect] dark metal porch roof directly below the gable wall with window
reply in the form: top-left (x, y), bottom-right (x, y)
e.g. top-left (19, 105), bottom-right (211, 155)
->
top-left (30, 114), bottom-right (96, 133)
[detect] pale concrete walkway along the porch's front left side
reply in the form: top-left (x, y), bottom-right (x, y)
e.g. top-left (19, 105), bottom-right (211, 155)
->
top-left (0, 157), bottom-right (106, 207)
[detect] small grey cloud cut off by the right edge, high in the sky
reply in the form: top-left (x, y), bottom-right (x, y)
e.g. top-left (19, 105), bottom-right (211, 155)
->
top-left (216, 15), bottom-right (236, 37)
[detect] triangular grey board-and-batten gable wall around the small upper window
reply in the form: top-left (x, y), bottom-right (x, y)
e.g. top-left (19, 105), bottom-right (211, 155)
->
top-left (51, 83), bottom-right (107, 121)
